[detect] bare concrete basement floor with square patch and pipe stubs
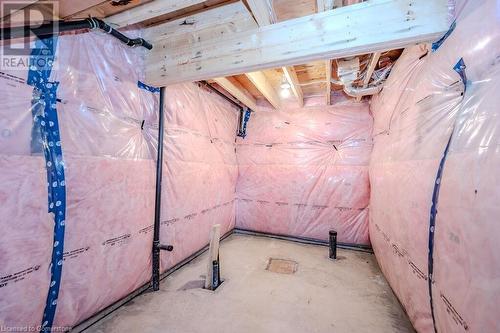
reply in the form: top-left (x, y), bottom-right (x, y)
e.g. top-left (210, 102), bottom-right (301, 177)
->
top-left (85, 234), bottom-right (414, 333)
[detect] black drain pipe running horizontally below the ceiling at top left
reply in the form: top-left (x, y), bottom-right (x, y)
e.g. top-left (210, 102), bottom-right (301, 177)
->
top-left (0, 17), bottom-right (153, 50)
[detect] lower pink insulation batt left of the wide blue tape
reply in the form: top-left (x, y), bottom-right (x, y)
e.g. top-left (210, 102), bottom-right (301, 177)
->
top-left (0, 155), bottom-right (53, 327)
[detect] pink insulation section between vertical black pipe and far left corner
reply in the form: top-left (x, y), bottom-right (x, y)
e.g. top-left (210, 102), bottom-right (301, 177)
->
top-left (161, 84), bottom-right (238, 269)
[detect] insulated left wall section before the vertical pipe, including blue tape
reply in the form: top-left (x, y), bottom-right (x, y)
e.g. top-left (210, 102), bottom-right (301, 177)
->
top-left (0, 34), bottom-right (156, 327)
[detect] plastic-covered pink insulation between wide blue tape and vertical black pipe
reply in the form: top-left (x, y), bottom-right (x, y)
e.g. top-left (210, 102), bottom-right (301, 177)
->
top-left (52, 34), bottom-right (156, 326)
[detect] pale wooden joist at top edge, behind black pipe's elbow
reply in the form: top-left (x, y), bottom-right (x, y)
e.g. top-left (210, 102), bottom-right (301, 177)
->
top-left (106, 0), bottom-right (205, 28)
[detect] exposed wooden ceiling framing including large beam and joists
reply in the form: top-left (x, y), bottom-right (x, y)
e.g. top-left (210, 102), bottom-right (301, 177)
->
top-left (2, 0), bottom-right (448, 109)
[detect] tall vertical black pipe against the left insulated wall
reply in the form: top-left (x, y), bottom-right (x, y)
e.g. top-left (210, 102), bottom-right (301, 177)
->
top-left (152, 87), bottom-right (165, 291)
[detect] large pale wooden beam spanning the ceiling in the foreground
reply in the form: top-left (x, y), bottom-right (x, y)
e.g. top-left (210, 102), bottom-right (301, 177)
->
top-left (146, 0), bottom-right (449, 86)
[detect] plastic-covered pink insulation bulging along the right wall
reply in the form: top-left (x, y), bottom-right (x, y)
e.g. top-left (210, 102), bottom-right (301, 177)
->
top-left (370, 0), bottom-right (500, 332)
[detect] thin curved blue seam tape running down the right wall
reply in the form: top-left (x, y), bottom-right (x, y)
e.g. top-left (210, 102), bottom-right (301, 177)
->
top-left (427, 58), bottom-right (467, 333)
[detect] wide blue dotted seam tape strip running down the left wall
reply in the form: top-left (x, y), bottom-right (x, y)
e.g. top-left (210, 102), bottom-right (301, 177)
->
top-left (27, 37), bottom-right (66, 332)
